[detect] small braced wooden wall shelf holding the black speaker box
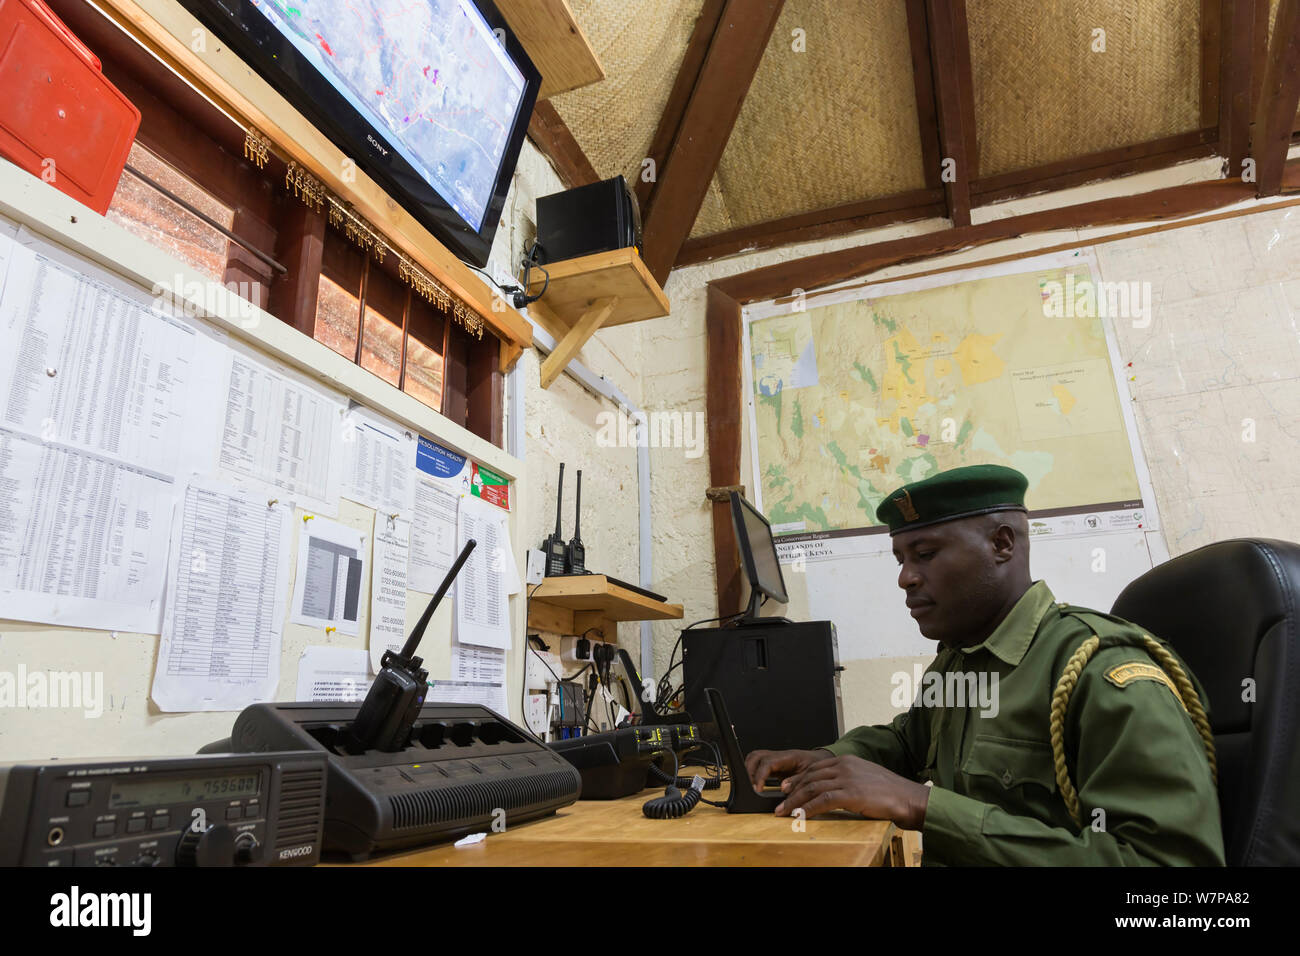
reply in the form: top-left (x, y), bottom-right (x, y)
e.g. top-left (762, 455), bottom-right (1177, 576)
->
top-left (528, 246), bottom-right (670, 389)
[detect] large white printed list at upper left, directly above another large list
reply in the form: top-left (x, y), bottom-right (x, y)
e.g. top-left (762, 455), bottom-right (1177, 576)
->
top-left (0, 232), bottom-right (226, 476)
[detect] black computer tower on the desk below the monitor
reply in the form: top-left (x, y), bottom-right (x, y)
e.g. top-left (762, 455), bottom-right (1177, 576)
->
top-left (681, 620), bottom-right (844, 753)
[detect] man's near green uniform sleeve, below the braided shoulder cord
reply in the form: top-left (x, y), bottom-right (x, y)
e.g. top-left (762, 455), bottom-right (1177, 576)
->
top-left (923, 648), bottom-right (1223, 866)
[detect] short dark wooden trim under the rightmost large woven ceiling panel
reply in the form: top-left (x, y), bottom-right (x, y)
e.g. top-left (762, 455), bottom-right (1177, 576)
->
top-left (971, 126), bottom-right (1219, 206)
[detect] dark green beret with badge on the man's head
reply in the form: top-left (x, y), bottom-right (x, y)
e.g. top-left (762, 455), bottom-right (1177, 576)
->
top-left (876, 464), bottom-right (1030, 536)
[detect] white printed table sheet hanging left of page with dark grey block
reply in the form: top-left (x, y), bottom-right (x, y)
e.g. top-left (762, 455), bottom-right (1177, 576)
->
top-left (152, 480), bottom-right (291, 711)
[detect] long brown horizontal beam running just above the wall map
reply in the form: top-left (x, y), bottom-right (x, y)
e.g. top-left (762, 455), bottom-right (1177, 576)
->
top-left (711, 171), bottom-right (1268, 303)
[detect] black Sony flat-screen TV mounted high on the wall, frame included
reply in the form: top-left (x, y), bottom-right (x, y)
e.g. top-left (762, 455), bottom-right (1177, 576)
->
top-left (182, 0), bottom-right (541, 265)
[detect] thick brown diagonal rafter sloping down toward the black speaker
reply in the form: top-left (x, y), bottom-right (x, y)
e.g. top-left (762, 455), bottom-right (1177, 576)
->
top-left (642, 0), bottom-right (784, 285)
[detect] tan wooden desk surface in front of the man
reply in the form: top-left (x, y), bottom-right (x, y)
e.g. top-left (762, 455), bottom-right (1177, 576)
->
top-left (338, 783), bottom-right (901, 866)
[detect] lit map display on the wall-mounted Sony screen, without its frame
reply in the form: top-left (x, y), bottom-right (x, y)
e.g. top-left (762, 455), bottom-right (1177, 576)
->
top-left (259, 0), bottom-right (525, 229)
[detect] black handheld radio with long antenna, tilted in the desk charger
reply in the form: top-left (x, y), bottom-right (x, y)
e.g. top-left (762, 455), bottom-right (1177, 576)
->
top-left (346, 538), bottom-right (477, 753)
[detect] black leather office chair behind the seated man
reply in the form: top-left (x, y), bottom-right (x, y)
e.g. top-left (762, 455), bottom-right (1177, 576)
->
top-left (1112, 538), bottom-right (1300, 866)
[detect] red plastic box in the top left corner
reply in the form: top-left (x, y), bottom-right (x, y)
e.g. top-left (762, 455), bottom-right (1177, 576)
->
top-left (0, 0), bottom-right (140, 216)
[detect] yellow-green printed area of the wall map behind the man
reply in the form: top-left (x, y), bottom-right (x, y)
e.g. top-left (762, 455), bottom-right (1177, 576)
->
top-left (749, 265), bottom-right (1140, 535)
